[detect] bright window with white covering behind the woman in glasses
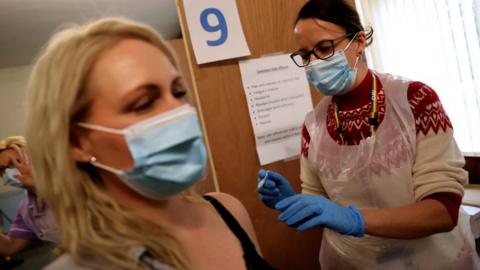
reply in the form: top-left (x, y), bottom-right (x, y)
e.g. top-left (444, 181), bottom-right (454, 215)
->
top-left (356, 0), bottom-right (480, 156)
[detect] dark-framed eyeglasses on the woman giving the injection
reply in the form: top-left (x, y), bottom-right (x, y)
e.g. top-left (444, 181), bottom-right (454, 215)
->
top-left (290, 33), bottom-right (354, 67)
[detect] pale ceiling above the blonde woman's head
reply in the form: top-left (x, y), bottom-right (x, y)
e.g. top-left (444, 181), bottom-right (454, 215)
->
top-left (0, 0), bottom-right (181, 69)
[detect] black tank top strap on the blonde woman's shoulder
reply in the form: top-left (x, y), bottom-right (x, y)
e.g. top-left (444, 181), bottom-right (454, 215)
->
top-left (203, 195), bottom-right (275, 270)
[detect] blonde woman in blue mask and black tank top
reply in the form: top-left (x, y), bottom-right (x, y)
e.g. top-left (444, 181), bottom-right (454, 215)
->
top-left (27, 18), bottom-right (269, 269)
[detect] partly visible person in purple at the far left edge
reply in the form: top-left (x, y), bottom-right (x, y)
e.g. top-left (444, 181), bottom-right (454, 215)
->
top-left (0, 136), bottom-right (59, 256)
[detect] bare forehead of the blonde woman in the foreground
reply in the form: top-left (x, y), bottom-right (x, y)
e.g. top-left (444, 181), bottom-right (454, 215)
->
top-left (87, 39), bottom-right (177, 99)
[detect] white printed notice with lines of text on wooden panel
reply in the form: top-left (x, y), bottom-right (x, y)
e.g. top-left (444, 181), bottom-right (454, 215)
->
top-left (240, 55), bottom-right (312, 165)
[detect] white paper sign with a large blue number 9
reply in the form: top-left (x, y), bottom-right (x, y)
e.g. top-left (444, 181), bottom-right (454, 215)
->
top-left (184, 0), bottom-right (250, 64)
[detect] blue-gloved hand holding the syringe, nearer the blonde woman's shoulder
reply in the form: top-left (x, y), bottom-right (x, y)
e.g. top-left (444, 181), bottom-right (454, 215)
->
top-left (257, 169), bottom-right (295, 209)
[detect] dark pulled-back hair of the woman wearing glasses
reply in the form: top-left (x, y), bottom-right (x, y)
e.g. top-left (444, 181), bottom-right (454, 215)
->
top-left (295, 0), bottom-right (373, 46)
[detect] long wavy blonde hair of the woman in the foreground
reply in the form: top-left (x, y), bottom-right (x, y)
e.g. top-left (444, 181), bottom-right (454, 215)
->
top-left (27, 18), bottom-right (193, 269)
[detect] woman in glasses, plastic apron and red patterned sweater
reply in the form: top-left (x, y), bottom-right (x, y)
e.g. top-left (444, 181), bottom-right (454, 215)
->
top-left (259, 0), bottom-right (479, 270)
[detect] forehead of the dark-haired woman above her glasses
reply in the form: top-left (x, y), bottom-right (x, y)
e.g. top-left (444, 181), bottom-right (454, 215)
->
top-left (294, 18), bottom-right (345, 49)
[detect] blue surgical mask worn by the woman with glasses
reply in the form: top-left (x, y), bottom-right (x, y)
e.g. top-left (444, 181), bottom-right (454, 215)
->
top-left (305, 35), bottom-right (359, 96)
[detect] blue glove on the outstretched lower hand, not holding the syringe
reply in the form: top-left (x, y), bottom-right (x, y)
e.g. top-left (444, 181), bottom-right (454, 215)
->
top-left (275, 194), bottom-right (365, 237)
